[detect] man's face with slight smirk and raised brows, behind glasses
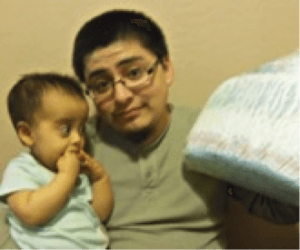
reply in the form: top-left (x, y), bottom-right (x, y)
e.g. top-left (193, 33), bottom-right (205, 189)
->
top-left (85, 40), bottom-right (173, 137)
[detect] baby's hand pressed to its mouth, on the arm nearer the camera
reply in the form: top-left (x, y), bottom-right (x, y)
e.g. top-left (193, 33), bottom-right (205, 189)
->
top-left (57, 147), bottom-right (80, 177)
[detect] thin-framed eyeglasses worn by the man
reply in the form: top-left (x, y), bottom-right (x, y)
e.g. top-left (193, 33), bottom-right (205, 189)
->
top-left (85, 59), bottom-right (159, 101)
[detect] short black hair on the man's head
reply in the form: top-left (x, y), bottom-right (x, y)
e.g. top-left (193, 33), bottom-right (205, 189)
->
top-left (73, 10), bottom-right (168, 82)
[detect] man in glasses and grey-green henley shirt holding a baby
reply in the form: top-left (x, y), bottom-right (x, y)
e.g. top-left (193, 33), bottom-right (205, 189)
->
top-left (73, 10), bottom-right (298, 250)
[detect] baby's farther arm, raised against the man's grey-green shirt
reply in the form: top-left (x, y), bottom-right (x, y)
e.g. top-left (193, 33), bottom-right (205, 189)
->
top-left (81, 151), bottom-right (114, 222)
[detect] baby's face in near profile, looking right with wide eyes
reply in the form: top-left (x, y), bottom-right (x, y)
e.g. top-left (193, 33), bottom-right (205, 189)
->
top-left (30, 89), bottom-right (89, 171)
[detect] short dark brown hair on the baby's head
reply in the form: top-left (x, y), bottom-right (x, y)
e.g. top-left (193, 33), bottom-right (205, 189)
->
top-left (7, 73), bottom-right (85, 129)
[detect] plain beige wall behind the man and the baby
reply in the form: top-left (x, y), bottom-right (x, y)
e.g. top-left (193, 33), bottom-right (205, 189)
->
top-left (0, 0), bottom-right (300, 248)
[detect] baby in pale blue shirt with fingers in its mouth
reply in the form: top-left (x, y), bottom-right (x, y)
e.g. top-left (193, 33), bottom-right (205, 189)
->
top-left (0, 73), bottom-right (113, 250)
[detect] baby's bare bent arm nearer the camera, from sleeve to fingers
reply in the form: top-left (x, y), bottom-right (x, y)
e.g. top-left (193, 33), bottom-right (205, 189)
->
top-left (8, 147), bottom-right (80, 226)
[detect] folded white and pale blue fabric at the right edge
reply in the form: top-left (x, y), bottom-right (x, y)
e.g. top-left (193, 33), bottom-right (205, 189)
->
top-left (185, 50), bottom-right (300, 206)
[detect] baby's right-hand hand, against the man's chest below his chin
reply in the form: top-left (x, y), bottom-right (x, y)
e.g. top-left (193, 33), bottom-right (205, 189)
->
top-left (79, 150), bottom-right (107, 181)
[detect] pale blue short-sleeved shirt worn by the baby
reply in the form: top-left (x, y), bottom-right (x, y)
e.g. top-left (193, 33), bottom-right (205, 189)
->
top-left (0, 153), bottom-right (108, 250)
